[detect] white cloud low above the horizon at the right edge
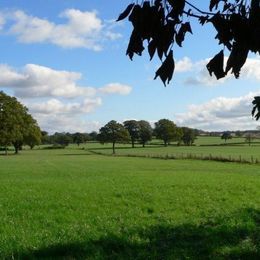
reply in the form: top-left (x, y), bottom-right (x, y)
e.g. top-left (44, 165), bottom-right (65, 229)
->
top-left (175, 92), bottom-right (260, 130)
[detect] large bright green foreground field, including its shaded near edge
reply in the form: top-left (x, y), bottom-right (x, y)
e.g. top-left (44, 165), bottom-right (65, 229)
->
top-left (0, 144), bottom-right (260, 259)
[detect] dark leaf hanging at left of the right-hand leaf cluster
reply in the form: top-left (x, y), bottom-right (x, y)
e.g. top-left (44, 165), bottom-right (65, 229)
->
top-left (207, 50), bottom-right (225, 79)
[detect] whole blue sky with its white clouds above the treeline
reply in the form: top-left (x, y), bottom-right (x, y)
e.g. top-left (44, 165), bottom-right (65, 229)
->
top-left (0, 0), bottom-right (260, 132)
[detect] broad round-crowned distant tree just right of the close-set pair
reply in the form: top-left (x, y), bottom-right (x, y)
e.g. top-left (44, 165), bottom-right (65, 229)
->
top-left (154, 119), bottom-right (181, 146)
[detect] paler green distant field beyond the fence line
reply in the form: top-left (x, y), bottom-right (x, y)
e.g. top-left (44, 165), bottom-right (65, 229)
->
top-left (86, 137), bottom-right (260, 163)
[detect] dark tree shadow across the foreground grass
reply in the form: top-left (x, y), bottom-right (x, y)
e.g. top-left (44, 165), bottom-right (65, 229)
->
top-left (11, 209), bottom-right (260, 259)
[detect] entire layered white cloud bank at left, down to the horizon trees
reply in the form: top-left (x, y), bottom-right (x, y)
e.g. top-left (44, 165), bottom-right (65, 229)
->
top-left (0, 64), bottom-right (132, 132)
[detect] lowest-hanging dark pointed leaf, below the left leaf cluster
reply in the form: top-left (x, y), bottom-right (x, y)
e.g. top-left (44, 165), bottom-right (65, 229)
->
top-left (154, 50), bottom-right (175, 86)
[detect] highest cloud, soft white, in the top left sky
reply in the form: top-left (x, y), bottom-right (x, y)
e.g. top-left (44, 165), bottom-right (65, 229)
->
top-left (0, 9), bottom-right (121, 51)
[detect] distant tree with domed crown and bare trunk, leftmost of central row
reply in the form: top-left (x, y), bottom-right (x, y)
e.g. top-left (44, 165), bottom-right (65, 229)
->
top-left (97, 120), bottom-right (130, 154)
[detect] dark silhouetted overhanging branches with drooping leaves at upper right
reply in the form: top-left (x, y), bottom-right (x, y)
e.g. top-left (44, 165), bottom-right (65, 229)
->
top-left (117, 0), bottom-right (260, 117)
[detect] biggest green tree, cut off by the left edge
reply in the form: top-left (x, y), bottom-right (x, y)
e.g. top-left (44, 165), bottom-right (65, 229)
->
top-left (0, 91), bottom-right (39, 154)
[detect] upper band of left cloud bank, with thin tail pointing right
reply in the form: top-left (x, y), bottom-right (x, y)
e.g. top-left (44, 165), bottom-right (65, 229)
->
top-left (0, 64), bottom-right (132, 98)
